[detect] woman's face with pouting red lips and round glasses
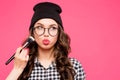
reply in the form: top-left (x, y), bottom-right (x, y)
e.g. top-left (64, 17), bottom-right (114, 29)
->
top-left (33, 18), bottom-right (58, 49)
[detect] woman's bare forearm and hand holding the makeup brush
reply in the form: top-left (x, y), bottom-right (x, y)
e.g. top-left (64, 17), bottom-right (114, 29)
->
top-left (6, 47), bottom-right (29, 80)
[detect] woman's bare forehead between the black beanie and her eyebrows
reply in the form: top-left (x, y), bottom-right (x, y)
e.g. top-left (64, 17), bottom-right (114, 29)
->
top-left (35, 18), bottom-right (58, 26)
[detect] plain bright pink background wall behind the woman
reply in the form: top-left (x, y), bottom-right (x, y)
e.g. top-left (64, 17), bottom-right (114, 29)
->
top-left (0, 0), bottom-right (120, 80)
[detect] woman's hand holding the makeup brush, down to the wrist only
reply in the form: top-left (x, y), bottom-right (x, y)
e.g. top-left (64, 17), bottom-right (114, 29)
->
top-left (14, 47), bottom-right (29, 70)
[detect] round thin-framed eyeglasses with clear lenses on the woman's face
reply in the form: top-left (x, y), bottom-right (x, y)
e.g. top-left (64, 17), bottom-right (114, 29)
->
top-left (33, 26), bottom-right (58, 37)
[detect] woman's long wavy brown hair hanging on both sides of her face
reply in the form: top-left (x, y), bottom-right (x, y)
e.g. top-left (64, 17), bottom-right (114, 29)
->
top-left (18, 25), bottom-right (75, 80)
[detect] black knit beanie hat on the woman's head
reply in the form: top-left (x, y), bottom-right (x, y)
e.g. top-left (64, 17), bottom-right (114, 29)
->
top-left (29, 2), bottom-right (63, 30)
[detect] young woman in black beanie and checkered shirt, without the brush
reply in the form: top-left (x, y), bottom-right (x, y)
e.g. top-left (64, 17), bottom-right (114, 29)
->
top-left (6, 2), bottom-right (85, 80)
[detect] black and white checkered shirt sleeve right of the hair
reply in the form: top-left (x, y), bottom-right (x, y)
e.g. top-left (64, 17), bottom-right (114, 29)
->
top-left (70, 58), bottom-right (86, 80)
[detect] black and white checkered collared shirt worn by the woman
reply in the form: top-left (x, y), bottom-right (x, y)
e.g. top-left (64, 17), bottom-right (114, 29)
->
top-left (28, 58), bottom-right (85, 80)
